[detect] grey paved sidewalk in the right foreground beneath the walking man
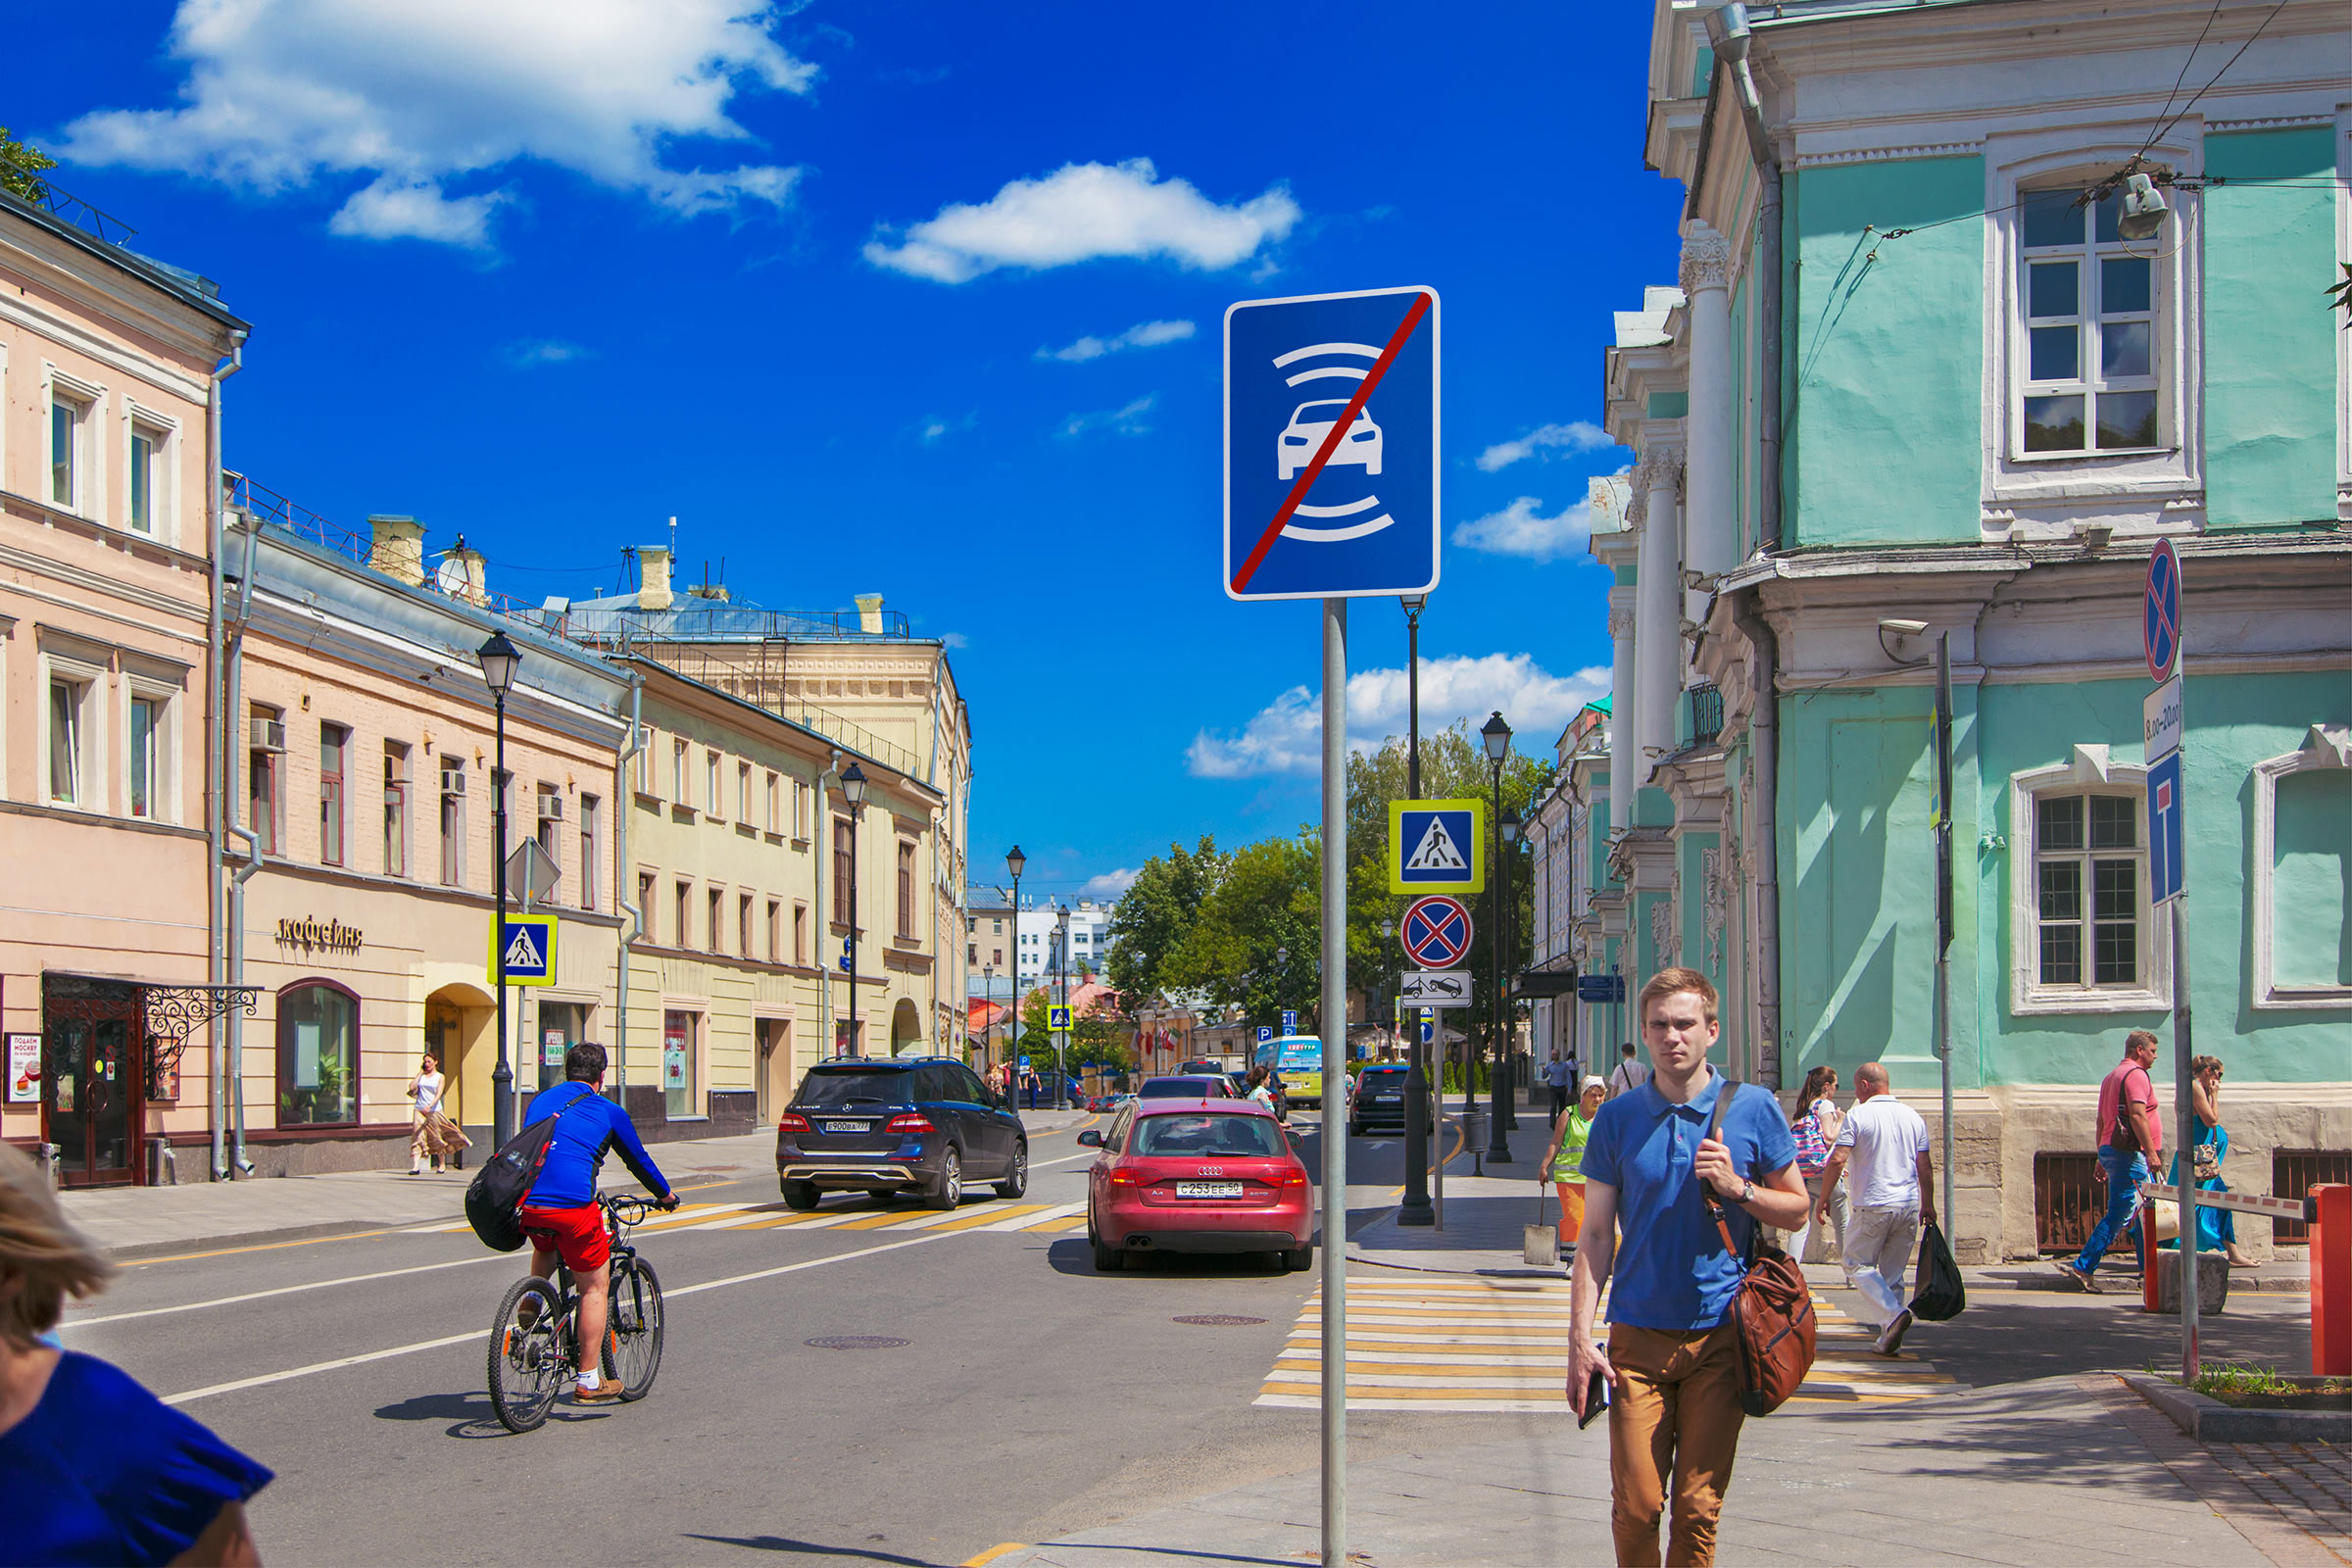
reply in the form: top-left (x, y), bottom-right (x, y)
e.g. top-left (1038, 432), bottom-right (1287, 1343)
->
top-left (974, 1375), bottom-right (2342, 1568)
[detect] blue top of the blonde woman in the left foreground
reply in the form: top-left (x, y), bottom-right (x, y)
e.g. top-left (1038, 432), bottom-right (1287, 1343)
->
top-left (0, 1349), bottom-right (270, 1563)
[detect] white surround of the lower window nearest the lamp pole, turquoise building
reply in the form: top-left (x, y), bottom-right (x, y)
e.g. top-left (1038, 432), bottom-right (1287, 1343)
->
top-left (2009, 745), bottom-right (2174, 1018)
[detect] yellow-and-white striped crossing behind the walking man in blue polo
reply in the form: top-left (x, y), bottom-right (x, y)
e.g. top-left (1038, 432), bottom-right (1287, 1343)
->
top-left (1256, 1274), bottom-right (1959, 1415)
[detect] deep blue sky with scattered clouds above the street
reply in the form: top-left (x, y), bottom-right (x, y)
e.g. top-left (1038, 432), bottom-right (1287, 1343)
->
top-left (7, 0), bottom-right (1677, 894)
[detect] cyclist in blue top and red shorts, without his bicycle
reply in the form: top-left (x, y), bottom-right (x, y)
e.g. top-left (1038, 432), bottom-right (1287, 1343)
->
top-left (522, 1042), bottom-right (677, 1403)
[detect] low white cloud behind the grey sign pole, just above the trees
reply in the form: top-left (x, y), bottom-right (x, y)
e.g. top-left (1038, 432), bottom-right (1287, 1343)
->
top-left (1186, 654), bottom-right (1609, 778)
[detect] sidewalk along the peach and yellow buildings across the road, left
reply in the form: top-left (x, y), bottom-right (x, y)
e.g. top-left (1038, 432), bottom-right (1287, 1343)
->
top-left (59, 1109), bottom-right (1089, 1262)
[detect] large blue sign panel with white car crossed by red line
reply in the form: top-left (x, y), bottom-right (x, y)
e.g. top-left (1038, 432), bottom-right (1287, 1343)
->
top-left (1225, 289), bottom-right (1437, 600)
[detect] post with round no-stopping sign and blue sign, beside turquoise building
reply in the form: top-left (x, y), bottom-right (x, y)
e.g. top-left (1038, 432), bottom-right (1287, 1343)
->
top-left (2140, 538), bottom-right (2199, 1382)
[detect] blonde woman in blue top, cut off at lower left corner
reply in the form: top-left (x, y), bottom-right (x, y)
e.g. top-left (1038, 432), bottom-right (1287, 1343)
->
top-left (0, 1145), bottom-right (270, 1568)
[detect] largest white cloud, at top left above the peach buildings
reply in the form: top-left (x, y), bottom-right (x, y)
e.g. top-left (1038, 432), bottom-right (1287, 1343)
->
top-left (57, 0), bottom-right (816, 247)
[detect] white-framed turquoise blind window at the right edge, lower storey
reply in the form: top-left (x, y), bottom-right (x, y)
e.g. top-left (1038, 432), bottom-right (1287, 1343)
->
top-left (2248, 724), bottom-right (2352, 1008)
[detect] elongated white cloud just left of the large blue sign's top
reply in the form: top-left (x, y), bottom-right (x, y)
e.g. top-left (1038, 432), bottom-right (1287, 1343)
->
top-left (865, 158), bottom-right (1298, 282)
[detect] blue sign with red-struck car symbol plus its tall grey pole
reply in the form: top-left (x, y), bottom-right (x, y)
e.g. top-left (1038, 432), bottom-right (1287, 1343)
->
top-left (1221, 287), bottom-right (1440, 1568)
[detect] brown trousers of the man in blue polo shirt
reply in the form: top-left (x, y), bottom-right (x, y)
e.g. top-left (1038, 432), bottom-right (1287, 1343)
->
top-left (1609, 1324), bottom-right (1745, 1568)
